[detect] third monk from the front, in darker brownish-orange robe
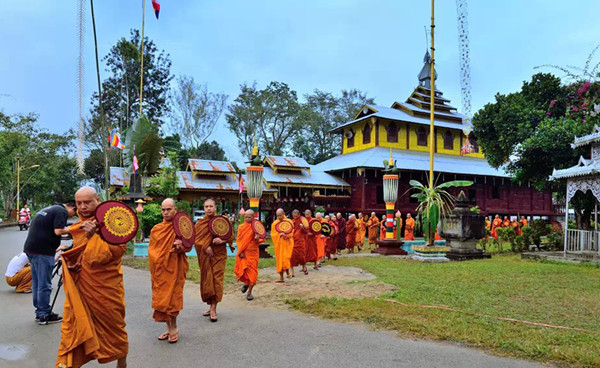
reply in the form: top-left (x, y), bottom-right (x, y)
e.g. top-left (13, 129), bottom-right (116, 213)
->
top-left (194, 198), bottom-right (234, 322)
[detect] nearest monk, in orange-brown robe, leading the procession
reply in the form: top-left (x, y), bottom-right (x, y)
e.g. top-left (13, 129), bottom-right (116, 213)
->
top-left (56, 187), bottom-right (129, 368)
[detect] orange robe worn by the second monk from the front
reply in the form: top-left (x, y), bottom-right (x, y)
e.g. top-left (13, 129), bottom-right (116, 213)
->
top-left (148, 221), bottom-right (189, 322)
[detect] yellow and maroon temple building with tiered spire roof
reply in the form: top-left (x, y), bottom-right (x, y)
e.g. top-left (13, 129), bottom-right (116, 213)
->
top-left (313, 54), bottom-right (553, 216)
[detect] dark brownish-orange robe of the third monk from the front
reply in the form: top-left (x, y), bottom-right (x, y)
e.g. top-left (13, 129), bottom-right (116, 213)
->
top-left (194, 215), bottom-right (233, 305)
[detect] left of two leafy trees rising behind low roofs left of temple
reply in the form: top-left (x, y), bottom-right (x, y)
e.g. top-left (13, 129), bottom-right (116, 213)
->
top-left (226, 82), bottom-right (302, 156)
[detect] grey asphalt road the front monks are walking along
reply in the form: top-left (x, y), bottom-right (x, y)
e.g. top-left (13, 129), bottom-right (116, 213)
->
top-left (0, 228), bottom-right (542, 368)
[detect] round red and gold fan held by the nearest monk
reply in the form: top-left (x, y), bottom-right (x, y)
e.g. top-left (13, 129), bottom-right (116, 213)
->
top-left (94, 201), bottom-right (139, 245)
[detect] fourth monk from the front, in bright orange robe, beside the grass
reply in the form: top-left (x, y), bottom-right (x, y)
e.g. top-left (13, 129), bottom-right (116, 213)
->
top-left (233, 210), bottom-right (265, 300)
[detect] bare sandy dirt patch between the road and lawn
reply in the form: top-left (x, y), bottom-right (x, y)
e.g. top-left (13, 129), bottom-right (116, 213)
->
top-left (225, 266), bottom-right (396, 309)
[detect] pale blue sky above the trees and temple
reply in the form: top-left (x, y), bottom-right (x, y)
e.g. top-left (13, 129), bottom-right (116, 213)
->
top-left (0, 0), bottom-right (600, 160)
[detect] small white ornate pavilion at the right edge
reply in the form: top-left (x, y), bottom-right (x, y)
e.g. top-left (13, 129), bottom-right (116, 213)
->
top-left (550, 125), bottom-right (600, 257)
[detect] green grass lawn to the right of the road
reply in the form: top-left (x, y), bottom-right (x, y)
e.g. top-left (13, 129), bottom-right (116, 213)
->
top-left (287, 254), bottom-right (600, 367)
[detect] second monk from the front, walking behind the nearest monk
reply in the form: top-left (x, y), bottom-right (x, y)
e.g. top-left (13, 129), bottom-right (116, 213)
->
top-left (148, 198), bottom-right (191, 343)
